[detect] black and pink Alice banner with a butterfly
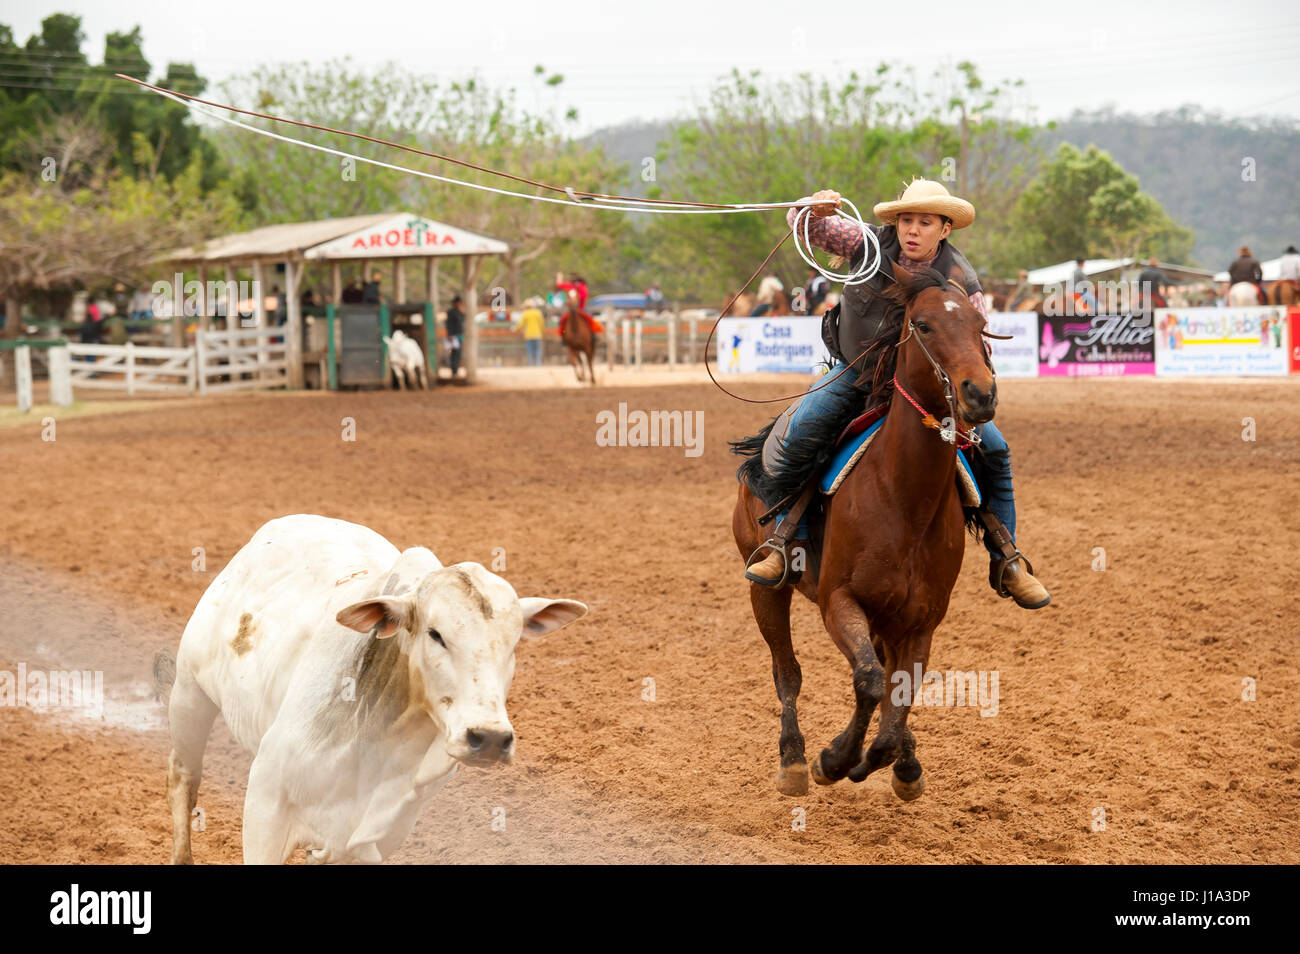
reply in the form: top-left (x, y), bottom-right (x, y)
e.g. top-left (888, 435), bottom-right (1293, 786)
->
top-left (1039, 315), bottom-right (1156, 377)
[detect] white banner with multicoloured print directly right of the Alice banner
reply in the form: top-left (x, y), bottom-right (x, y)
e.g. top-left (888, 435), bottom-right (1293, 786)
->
top-left (1156, 307), bottom-right (1290, 376)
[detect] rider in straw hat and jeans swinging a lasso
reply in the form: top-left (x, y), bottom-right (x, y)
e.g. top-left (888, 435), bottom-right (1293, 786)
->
top-left (745, 179), bottom-right (1052, 610)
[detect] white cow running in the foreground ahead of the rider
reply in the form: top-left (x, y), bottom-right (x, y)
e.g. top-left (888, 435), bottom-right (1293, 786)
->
top-left (168, 513), bottom-right (586, 864)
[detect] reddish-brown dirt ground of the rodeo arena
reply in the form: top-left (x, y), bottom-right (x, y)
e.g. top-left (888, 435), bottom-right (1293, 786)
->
top-left (0, 380), bottom-right (1300, 863)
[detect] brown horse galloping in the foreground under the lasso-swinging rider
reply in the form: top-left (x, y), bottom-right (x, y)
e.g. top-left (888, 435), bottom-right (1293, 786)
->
top-left (732, 266), bottom-right (997, 801)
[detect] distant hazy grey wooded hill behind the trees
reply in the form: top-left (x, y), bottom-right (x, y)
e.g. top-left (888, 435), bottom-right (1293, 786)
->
top-left (584, 107), bottom-right (1300, 269)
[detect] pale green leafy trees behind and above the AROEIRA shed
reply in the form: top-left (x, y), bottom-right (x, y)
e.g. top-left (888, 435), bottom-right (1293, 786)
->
top-left (218, 60), bottom-right (624, 300)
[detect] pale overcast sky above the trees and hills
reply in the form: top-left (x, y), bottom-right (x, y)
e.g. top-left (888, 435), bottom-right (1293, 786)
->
top-left (0, 0), bottom-right (1300, 133)
